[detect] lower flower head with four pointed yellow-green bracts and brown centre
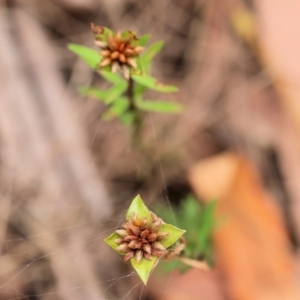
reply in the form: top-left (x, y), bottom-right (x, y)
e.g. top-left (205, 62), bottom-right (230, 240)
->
top-left (105, 195), bottom-right (185, 284)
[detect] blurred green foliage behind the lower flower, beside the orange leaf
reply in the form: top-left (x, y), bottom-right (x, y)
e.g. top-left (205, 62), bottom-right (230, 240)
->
top-left (156, 195), bottom-right (216, 270)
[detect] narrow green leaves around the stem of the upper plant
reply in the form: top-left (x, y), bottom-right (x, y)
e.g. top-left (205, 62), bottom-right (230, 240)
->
top-left (68, 27), bottom-right (184, 126)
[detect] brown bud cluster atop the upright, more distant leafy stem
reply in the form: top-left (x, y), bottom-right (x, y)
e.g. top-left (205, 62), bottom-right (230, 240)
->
top-left (91, 23), bottom-right (144, 79)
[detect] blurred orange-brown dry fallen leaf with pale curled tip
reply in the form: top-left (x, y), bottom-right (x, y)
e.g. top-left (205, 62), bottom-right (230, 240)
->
top-left (190, 153), bottom-right (300, 300)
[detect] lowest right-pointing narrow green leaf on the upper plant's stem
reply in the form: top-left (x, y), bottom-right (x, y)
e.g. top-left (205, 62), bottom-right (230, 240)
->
top-left (137, 100), bottom-right (184, 113)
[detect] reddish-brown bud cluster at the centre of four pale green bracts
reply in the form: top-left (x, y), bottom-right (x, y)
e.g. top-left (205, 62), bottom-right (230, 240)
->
top-left (115, 212), bottom-right (169, 261)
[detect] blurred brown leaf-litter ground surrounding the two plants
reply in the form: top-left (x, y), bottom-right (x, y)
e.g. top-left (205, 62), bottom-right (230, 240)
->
top-left (0, 0), bottom-right (300, 300)
